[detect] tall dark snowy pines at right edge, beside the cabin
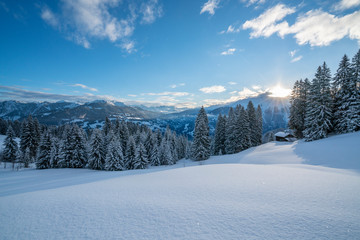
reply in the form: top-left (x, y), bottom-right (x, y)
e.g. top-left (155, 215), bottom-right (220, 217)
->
top-left (289, 50), bottom-right (360, 141)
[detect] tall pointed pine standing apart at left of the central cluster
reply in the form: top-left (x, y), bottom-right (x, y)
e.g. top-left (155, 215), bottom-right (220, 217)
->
top-left (193, 107), bottom-right (210, 161)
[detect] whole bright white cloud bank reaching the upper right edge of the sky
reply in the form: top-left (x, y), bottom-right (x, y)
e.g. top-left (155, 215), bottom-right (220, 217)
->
top-left (243, 4), bottom-right (360, 46)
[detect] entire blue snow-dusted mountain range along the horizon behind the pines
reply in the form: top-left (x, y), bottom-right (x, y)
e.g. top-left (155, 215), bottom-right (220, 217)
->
top-left (0, 93), bottom-right (289, 137)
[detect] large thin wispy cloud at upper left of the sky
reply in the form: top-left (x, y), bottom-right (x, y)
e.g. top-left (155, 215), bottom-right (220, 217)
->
top-left (41, 0), bottom-right (162, 49)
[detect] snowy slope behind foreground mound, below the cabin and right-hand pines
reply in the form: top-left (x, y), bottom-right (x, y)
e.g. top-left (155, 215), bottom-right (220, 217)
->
top-left (207, 132), bottom-right (360, 171)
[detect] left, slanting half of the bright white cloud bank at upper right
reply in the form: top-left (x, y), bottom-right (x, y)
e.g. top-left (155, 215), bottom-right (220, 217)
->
top-left (243, 4), bottom-right (295, 38)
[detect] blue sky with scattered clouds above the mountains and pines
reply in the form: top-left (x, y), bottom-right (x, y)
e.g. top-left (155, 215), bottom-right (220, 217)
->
top-left (0, 0), bottom-right (360, 107)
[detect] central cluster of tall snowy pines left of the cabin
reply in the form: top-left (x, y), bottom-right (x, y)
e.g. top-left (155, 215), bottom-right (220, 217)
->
top-left (192, 101), bottom-right (263, 160)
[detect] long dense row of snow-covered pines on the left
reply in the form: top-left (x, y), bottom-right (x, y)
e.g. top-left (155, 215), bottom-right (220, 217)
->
top-left (2, 116), bottom-right (190, 171)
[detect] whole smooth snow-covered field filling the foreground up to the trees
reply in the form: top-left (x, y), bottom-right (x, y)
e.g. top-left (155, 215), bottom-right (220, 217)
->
top-left (0, 132), bottom-right (360, 239)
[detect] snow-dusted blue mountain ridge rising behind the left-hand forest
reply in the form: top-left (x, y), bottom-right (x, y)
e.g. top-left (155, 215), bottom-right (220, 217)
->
top-left (0, 100), bottom-right (160, 125)
